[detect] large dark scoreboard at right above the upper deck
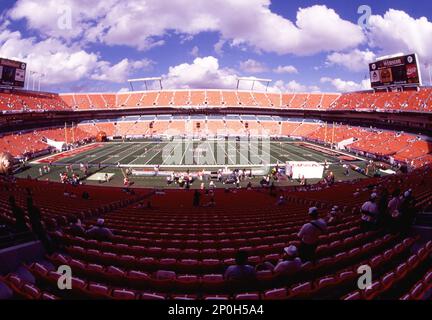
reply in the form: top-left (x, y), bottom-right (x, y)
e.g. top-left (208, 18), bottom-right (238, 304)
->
top-left (369, 53), bottom-right (422, 88)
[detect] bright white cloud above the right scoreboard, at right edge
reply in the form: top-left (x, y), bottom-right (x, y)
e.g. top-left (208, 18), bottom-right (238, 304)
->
top-left (367, 9), bottom-right (432, 63)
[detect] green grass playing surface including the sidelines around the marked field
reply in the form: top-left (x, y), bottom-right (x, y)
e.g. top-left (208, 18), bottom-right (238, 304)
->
top-left (18, 140), bottom-right (365, 188)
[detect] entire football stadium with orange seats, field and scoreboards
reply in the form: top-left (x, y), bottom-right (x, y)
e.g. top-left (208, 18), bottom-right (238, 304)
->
top-left (0, 0), bottom-right (432, 302)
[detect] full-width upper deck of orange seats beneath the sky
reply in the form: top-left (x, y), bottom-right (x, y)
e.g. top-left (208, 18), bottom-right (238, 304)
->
top-left (0, 88), bottom-right (432, 113)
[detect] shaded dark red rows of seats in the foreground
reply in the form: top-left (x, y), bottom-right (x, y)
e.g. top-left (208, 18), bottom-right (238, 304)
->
top-left (0, 168), bottom-right (432, 300)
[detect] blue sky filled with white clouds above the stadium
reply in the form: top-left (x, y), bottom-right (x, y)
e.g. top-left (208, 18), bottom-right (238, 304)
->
top-left (0, 0), bottom-right (432, 92)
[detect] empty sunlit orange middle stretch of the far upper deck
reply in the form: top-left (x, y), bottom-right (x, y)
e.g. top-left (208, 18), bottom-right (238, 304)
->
top-left (60, 90), bottom-right (340, 110)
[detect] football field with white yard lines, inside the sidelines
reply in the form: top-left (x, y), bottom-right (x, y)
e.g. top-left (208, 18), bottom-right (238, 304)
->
top-left (37, 140), bottom-right (354, 169)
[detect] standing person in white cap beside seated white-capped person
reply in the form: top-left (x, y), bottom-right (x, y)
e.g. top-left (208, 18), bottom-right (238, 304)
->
top-left (298, 207), bottom-right (327, 261)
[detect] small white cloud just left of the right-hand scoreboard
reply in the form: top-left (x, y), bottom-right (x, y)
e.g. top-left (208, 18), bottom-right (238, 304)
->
top-left (326, 49), bottom-right (376, 72)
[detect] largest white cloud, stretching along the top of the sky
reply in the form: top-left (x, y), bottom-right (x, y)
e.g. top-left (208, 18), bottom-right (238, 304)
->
top-left (10, 0), bottom-right (365, 55)
